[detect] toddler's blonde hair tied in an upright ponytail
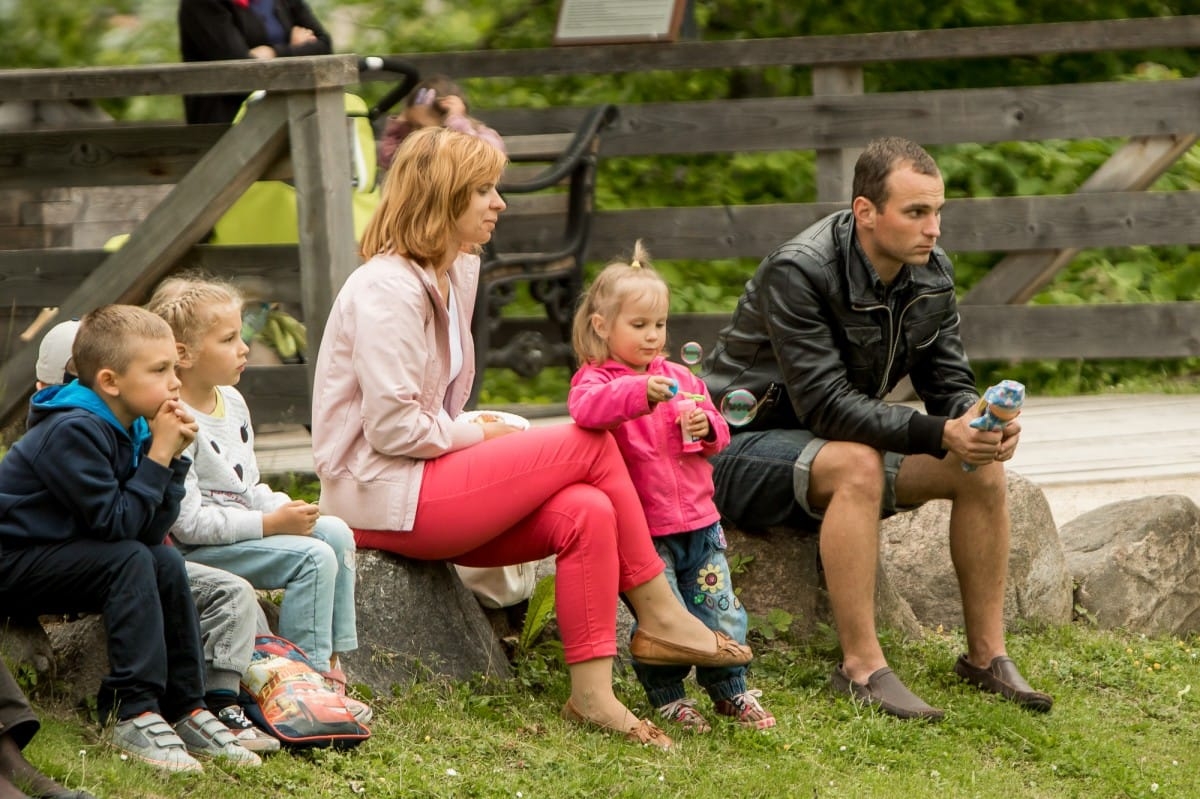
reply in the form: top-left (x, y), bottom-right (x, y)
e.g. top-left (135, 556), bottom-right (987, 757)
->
top-left (571, 239), bottom-right (670, 364)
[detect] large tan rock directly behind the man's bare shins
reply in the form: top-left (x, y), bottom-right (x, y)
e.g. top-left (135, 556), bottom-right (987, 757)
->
top-left (882, 471), bottom-right (1072, 627)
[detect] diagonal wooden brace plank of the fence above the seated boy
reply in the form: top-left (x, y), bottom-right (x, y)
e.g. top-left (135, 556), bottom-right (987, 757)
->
top-left (0, 95), bottom-right (291, 419)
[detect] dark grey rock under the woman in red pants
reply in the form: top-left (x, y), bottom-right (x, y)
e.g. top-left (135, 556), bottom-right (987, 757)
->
top-left (342, 549), bottom-right (510, 696)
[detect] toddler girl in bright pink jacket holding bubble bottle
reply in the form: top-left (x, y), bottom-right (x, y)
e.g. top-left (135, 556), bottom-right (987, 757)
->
top-left (568, 241), bottom-right (775, 733)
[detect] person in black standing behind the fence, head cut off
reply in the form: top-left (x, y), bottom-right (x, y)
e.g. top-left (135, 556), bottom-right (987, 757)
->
top-left (178, 0), bottom-right (334, 125)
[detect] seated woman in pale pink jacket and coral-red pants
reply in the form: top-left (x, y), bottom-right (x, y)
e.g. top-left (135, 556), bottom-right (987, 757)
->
top-left (312, 127), bottom-right (751, 749)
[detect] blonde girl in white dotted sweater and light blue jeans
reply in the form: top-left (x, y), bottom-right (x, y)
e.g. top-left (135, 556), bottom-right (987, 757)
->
top-left (149, 277), bottom-right (370, 723)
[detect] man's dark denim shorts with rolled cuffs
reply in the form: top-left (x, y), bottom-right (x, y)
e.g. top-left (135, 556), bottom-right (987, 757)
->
top-left (709, 429), bottom-right (917, 530)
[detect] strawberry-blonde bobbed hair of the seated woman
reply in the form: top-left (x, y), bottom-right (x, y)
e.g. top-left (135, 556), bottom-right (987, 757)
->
top-left (359, 127), bottom-right (508, 266)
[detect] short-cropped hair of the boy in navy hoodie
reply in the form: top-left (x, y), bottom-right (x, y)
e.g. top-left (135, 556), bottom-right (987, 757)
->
top-left (71, 305), bottom-right (172, 389)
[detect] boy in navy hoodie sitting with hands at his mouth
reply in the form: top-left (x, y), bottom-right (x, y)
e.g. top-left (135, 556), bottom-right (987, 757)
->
top-left (0, 305), bottom-right (262, 771)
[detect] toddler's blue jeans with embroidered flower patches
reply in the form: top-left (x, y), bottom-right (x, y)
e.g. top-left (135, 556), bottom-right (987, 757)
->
top-left (634, 523), bottom-right (748, 708)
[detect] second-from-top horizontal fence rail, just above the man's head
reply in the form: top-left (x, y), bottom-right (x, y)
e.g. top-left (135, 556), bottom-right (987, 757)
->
top-left (487, 78), bottom-right (1200, 156)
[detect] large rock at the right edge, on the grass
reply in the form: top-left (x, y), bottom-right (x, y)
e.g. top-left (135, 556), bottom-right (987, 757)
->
top-left (1061, 494), bottom-right (1200, 636)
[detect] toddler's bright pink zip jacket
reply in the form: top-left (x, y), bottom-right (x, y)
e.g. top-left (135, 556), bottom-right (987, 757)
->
top-left (566, 356), bottom-right (730, 535)
